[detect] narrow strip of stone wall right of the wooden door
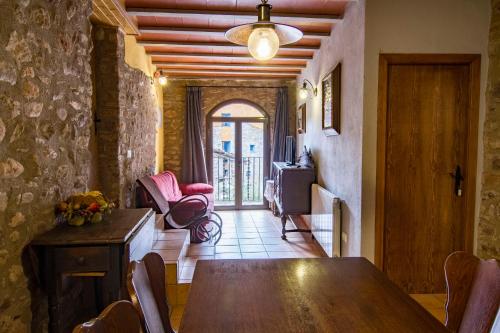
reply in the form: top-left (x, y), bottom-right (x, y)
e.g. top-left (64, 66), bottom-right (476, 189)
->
top-left (477, 0), bottom-right (500, 259)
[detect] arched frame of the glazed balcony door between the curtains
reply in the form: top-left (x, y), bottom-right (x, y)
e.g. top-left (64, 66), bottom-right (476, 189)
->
top-left (205, 99), bottom-right (271, 210)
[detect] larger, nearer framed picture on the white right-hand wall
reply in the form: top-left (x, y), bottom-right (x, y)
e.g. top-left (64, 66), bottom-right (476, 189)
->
top-left (322, 63), bottom-right (341, 136)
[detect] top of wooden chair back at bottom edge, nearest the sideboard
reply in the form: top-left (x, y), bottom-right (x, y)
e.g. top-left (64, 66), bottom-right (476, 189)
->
top-left (73, 301), bottom-right (142, 333)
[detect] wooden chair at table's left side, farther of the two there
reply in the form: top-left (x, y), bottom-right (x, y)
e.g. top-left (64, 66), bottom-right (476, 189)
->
top-left (127, 252), bottom-right (175, 333)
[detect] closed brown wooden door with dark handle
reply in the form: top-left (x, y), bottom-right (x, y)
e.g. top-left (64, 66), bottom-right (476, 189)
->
top-left (377, 55), bottom-right (479, 293)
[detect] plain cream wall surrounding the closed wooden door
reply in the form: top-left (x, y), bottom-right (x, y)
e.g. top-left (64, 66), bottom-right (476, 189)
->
top-left (361, 0), bottom-right (490, 261)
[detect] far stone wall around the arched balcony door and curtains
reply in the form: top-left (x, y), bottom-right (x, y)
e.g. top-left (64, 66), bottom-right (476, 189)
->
top-left (163, 79), bottom-right (296, 179)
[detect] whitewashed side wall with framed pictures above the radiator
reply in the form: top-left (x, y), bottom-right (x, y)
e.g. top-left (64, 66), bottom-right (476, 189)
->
top-left (297, 0), bottom-right (365, 256)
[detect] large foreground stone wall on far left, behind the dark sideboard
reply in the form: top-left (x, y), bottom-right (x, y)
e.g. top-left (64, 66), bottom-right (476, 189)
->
top-left (0, 0), bottom-right (93, 332)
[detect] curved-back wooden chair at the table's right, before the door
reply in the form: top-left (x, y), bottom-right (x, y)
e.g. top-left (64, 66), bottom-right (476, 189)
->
top-left (444, 251), bottom-right (500, 333)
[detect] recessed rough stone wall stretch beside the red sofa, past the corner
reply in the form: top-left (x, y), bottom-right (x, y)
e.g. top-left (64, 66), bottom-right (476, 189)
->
top-left (94, 26), bottom-right (158, 207)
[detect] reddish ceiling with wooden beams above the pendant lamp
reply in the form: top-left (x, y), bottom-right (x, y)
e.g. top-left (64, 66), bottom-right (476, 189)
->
top-left (124, 0), bottom-right (352, 79)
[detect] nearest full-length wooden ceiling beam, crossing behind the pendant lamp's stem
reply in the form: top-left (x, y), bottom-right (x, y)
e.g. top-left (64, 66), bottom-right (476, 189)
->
top-left (127, 7), bottom-right (342, 24)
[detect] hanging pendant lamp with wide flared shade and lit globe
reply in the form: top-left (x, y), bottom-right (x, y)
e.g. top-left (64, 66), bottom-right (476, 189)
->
top-left (226, 0), bottom-right (303, 61)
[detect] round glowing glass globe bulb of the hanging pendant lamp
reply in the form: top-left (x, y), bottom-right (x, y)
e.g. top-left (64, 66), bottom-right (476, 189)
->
top-left (248, 27), bottom-right (280, 61)
